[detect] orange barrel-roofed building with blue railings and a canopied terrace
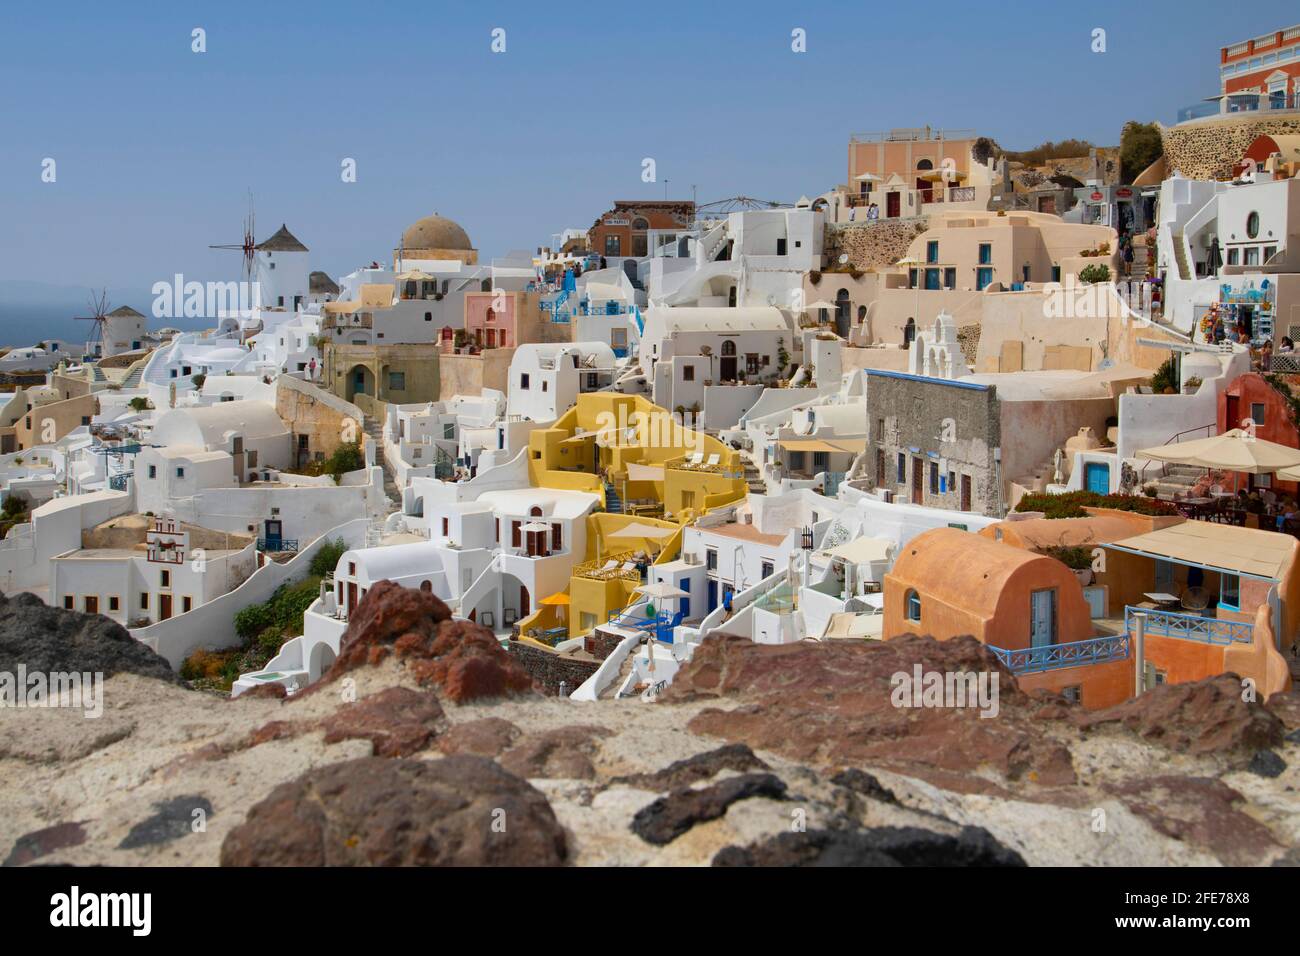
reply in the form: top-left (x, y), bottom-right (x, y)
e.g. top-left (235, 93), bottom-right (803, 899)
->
top-left (883, 509), bottom-right (1300, 708)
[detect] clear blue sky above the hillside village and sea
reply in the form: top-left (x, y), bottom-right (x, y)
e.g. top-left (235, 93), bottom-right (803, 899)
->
top-left (0, 0), bottom-right (1290, 308)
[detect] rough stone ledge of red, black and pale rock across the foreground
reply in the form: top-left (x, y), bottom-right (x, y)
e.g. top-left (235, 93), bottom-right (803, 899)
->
top-left (0, 583), bottom-right (1300, 866)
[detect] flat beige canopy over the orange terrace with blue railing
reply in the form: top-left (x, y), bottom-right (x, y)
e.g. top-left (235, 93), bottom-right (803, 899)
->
top-left (1102, 522), bottom-right (1296, 581)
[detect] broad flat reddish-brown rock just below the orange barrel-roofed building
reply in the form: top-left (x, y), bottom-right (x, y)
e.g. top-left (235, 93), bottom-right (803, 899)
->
top-left (662, 635), bottom-right (1075, 791)
